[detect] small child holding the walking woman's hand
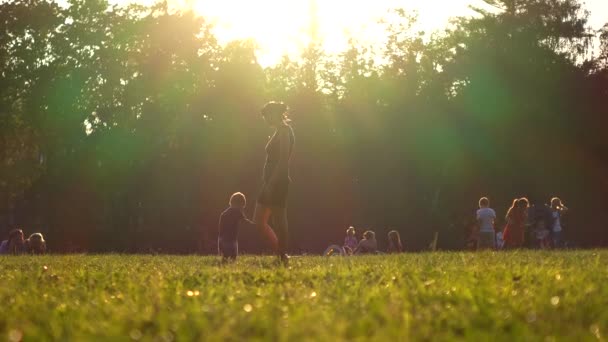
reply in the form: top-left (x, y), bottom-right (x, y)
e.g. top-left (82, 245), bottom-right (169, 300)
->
top-left (217, 192), bottom-right (254, 260)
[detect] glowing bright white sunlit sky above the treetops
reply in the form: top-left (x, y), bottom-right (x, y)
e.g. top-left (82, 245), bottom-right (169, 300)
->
top-left (180, 0), bottom-right (475, 66)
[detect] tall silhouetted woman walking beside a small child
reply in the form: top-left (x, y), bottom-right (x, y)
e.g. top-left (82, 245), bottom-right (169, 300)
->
top-left (254, 101), bottom-right (295, 263)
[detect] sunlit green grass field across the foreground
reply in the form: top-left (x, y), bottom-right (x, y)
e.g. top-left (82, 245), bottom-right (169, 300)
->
top-left (0, 251), bottom-right (608, 341)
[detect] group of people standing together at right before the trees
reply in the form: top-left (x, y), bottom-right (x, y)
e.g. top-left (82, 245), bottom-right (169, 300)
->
top-left (476, 197), bottom-right (568, 249)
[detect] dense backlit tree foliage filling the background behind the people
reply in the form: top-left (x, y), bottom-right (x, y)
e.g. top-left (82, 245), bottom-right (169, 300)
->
top-left (0, 0), bottom-right (608, 252)
